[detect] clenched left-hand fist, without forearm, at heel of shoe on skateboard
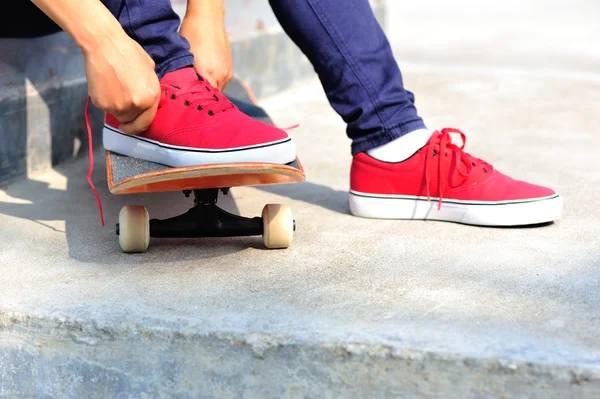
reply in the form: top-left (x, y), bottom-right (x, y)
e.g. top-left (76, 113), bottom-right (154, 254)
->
top-left (84, 35), bottom-right (161, 134)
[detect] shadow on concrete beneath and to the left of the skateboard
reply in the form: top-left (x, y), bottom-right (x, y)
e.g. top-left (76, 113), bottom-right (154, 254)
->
top-left (0, 155), bottom-right (262, 264)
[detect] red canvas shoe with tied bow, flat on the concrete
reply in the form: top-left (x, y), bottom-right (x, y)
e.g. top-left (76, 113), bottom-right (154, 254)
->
top-left (350, 128), bottom-right (563, 226)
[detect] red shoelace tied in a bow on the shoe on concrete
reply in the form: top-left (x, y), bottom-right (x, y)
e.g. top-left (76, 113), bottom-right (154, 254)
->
top-left (425, 127), bottom-right (491, 210)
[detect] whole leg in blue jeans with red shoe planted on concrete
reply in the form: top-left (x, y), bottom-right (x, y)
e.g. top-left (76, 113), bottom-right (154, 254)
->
top-left (271, 0), bottom-right (563, 226)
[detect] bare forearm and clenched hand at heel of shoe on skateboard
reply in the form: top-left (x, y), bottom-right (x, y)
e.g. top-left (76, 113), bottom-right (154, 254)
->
top-left (32, 0), bottom-right (161, 134)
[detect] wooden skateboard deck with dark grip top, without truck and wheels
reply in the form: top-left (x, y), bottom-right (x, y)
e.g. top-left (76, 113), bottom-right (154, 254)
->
top-left (106, 78), bottom-right (306, 194)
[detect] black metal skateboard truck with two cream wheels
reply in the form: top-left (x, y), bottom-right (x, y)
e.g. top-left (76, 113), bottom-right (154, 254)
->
top-left (116, 188), bottom-right (296, 252)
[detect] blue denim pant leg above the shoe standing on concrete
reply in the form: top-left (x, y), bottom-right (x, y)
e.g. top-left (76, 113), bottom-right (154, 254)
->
top-left (269, 0), bottom-right (425, 154)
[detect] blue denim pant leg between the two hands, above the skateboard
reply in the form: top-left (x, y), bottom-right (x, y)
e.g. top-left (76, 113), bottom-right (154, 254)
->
top-left (102, 0), bottom-right (194, 79)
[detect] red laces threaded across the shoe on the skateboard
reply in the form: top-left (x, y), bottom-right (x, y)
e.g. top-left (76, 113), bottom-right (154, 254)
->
top-left (161, 75), bottom-right (234, 116)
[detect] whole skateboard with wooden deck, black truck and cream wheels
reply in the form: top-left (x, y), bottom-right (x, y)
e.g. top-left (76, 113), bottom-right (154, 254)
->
top-left (106, 78), bottom-right (306, 253)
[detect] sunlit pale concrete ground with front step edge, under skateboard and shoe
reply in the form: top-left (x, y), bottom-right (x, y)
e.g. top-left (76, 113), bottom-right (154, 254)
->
top-left (0, 1), bottom-right (600, 398)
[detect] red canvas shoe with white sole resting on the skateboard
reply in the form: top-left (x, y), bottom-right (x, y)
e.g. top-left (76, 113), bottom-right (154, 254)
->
top-left (103, 67), bottom-right (296, 166)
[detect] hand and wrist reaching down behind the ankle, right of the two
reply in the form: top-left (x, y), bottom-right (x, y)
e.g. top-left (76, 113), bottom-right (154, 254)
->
top-left (179, 0), bottom-right (233, 91)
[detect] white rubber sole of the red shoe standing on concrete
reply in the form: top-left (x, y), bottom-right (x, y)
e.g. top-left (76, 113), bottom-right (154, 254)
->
top-left (350, 191), bottom-right (563, 226)
